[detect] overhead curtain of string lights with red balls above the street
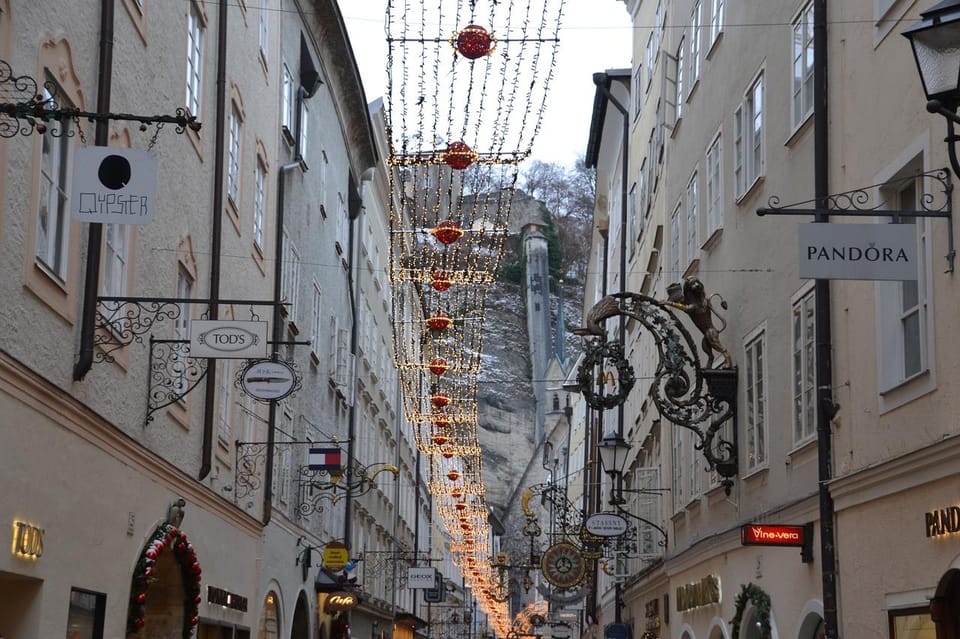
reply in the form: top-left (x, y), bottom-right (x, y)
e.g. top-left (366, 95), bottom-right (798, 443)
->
top-left (386, 0), bottom-right (564, 637)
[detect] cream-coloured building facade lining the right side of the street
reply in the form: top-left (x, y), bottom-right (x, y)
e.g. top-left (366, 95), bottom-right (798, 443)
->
top-left (584, 0), bottom-right (960, 639)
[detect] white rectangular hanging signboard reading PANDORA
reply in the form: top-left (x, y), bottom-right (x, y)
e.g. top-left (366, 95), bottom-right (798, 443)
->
top-left (798, 223), bottom-right (917, 280)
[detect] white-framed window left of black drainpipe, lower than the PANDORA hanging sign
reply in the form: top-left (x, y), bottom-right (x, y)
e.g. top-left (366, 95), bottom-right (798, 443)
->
top-left (790, 283), bottom-right (817, 446)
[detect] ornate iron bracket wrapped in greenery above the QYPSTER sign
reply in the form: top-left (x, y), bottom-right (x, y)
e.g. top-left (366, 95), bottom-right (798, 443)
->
top-left (0, 60), bottom-right (201, 138)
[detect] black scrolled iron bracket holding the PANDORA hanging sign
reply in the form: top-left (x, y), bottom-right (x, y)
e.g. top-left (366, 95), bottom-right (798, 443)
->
top-left (757, 168), bottom-right (957, 273)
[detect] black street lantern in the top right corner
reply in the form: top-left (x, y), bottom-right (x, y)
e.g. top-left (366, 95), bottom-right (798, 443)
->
top-left (903, 0), bottom-right (960, 175)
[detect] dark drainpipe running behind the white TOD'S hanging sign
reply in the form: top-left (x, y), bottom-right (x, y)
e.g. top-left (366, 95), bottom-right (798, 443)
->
top-left (197, 2), bottom-right (227, 479)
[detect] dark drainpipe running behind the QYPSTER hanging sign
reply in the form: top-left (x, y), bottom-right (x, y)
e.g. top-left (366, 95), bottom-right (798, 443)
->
top-left (73, 0), bottom-right (114, 382)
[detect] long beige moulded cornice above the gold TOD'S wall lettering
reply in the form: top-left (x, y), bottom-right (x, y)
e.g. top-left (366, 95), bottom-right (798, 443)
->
top-left (0, 351), bottom-right (263, 537)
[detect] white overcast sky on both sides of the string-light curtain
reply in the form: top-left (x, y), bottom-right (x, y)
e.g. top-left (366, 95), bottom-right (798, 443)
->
top-left (340, 0), bottom-right (631, 166)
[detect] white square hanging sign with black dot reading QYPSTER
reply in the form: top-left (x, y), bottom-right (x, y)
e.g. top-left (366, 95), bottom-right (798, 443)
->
top-left (70, 146), bottom-right (157, 224)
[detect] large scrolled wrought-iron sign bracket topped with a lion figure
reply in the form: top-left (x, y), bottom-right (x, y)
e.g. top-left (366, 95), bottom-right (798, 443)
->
top-left (577, 280), bottom-right (738, 490)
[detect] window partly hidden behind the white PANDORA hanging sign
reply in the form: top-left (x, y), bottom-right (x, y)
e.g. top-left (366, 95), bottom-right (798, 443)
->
top-left (877, 172), bottom-right (933, 391)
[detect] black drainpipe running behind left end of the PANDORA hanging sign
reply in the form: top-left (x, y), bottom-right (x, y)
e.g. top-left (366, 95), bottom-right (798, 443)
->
top-left (813, 0), bottom-right (839, 639)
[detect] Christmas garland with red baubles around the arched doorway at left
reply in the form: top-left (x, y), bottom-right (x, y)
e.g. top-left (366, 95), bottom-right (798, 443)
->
top-left (127, 523), bottom-right (202, 639)
